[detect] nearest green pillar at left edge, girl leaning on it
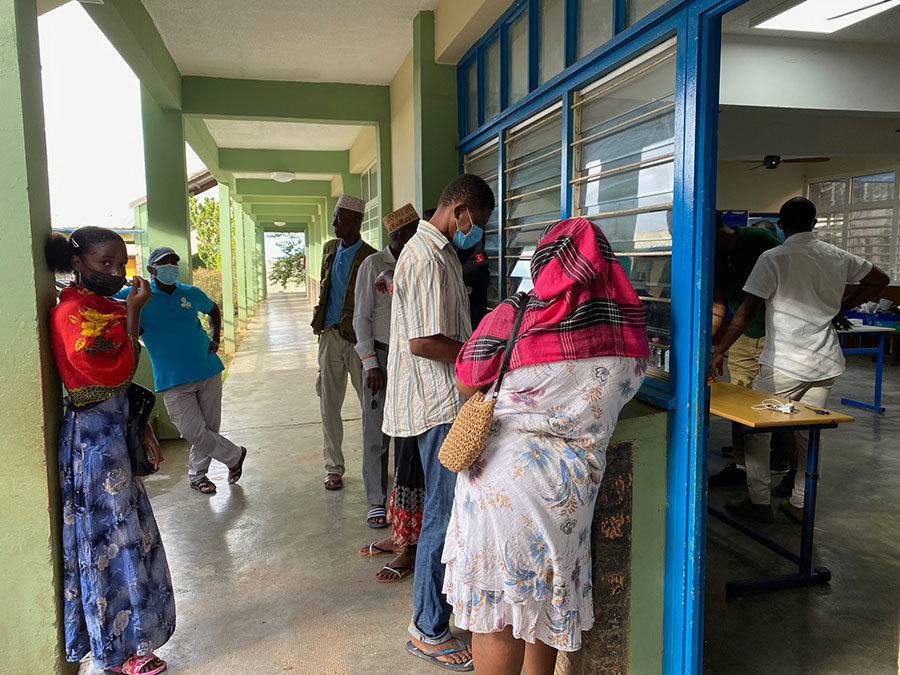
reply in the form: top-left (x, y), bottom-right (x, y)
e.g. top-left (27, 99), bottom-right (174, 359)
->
top-left (0, 0), bottom-right (77, 674)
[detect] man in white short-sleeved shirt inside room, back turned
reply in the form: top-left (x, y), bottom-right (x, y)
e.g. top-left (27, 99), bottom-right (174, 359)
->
top-left (710, 197), bottom-right (890, 523)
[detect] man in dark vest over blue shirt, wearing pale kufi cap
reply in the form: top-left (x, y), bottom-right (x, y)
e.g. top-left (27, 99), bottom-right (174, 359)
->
top-left (311, 195), bottom-right (375, 490)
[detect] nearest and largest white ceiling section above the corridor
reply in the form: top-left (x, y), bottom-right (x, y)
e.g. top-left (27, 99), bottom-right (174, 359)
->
top-left (142, 0), bottom-right (438, 84)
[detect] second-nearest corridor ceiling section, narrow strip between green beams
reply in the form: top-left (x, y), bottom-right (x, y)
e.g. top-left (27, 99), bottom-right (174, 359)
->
top-left (204, 119), bottom-right (363, 150)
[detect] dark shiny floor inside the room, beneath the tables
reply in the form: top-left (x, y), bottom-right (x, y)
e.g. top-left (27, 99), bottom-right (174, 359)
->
top-left (704, 356), bottom-right (900, 675)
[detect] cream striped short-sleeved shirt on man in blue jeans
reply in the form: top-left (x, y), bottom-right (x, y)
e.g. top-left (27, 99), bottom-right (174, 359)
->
top-left (383, 220), bottom-right (472, 437)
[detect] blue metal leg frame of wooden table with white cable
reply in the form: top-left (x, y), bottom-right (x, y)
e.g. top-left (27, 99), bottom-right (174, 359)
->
top-left (710, 428), bottom-right (831, 596)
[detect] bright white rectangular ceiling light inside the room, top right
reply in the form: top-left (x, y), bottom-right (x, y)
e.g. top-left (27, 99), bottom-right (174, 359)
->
top-left (750, 0), bottom-right (900, 33)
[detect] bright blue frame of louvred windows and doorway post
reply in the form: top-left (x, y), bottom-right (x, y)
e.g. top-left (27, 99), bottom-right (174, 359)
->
top-left (459, 0), bottom-right (746, 673)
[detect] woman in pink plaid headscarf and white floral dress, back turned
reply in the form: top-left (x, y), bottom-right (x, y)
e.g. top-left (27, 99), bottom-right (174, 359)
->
top-left (443, 218), bottom-right (648, 675)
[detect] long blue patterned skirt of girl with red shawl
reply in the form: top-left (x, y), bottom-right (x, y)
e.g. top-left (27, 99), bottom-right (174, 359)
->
top-left (59, 394), bottom-right (175, 669)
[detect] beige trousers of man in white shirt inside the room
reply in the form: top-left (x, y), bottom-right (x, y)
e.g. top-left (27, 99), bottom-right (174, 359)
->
top-left (744, 365), bottom-right (837, 508)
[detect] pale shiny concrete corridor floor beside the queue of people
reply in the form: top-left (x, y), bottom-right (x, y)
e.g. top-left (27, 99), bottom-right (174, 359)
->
top-left (126, 294), bottom-right (442, 675)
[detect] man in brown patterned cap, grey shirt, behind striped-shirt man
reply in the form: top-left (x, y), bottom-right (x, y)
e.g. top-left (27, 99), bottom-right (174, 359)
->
top-left (353, 204), bottom-right (419, 529)
